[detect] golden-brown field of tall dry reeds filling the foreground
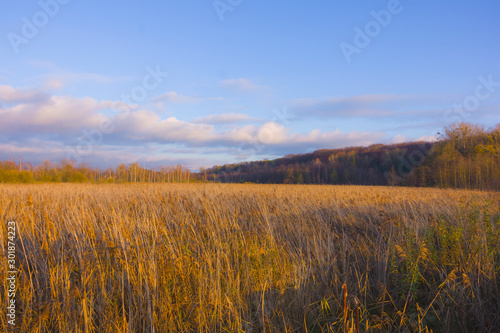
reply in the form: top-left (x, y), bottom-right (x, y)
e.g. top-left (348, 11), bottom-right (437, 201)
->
top-left (0, 184), bottom-right (500, 333)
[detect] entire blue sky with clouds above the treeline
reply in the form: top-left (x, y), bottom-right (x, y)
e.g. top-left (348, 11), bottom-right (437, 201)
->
top-left (0, 0), bottom-right (500, 171)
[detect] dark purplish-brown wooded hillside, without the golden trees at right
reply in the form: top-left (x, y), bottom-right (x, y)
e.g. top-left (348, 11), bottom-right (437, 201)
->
top-left (202, 142), bottom-right (434, 185)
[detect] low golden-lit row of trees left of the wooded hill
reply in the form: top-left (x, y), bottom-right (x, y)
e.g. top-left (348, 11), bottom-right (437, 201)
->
top-left (0, 159), bottom-right (196, 183)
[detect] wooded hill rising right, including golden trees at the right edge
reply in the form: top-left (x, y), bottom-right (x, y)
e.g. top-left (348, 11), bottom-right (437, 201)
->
top-left (206, 123), bottom-right (500, 190)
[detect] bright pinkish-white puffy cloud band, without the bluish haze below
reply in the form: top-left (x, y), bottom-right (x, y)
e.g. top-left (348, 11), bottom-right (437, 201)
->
top-left (0, 87), bottom-right (386, 145)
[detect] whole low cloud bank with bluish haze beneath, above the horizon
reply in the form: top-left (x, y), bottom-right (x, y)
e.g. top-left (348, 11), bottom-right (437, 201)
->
top-left (0, 82), bottom-right (408, 165)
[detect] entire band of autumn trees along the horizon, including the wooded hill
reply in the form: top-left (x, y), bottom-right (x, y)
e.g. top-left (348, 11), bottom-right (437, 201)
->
top-left (0, 123), bottom-right (500, 190)
